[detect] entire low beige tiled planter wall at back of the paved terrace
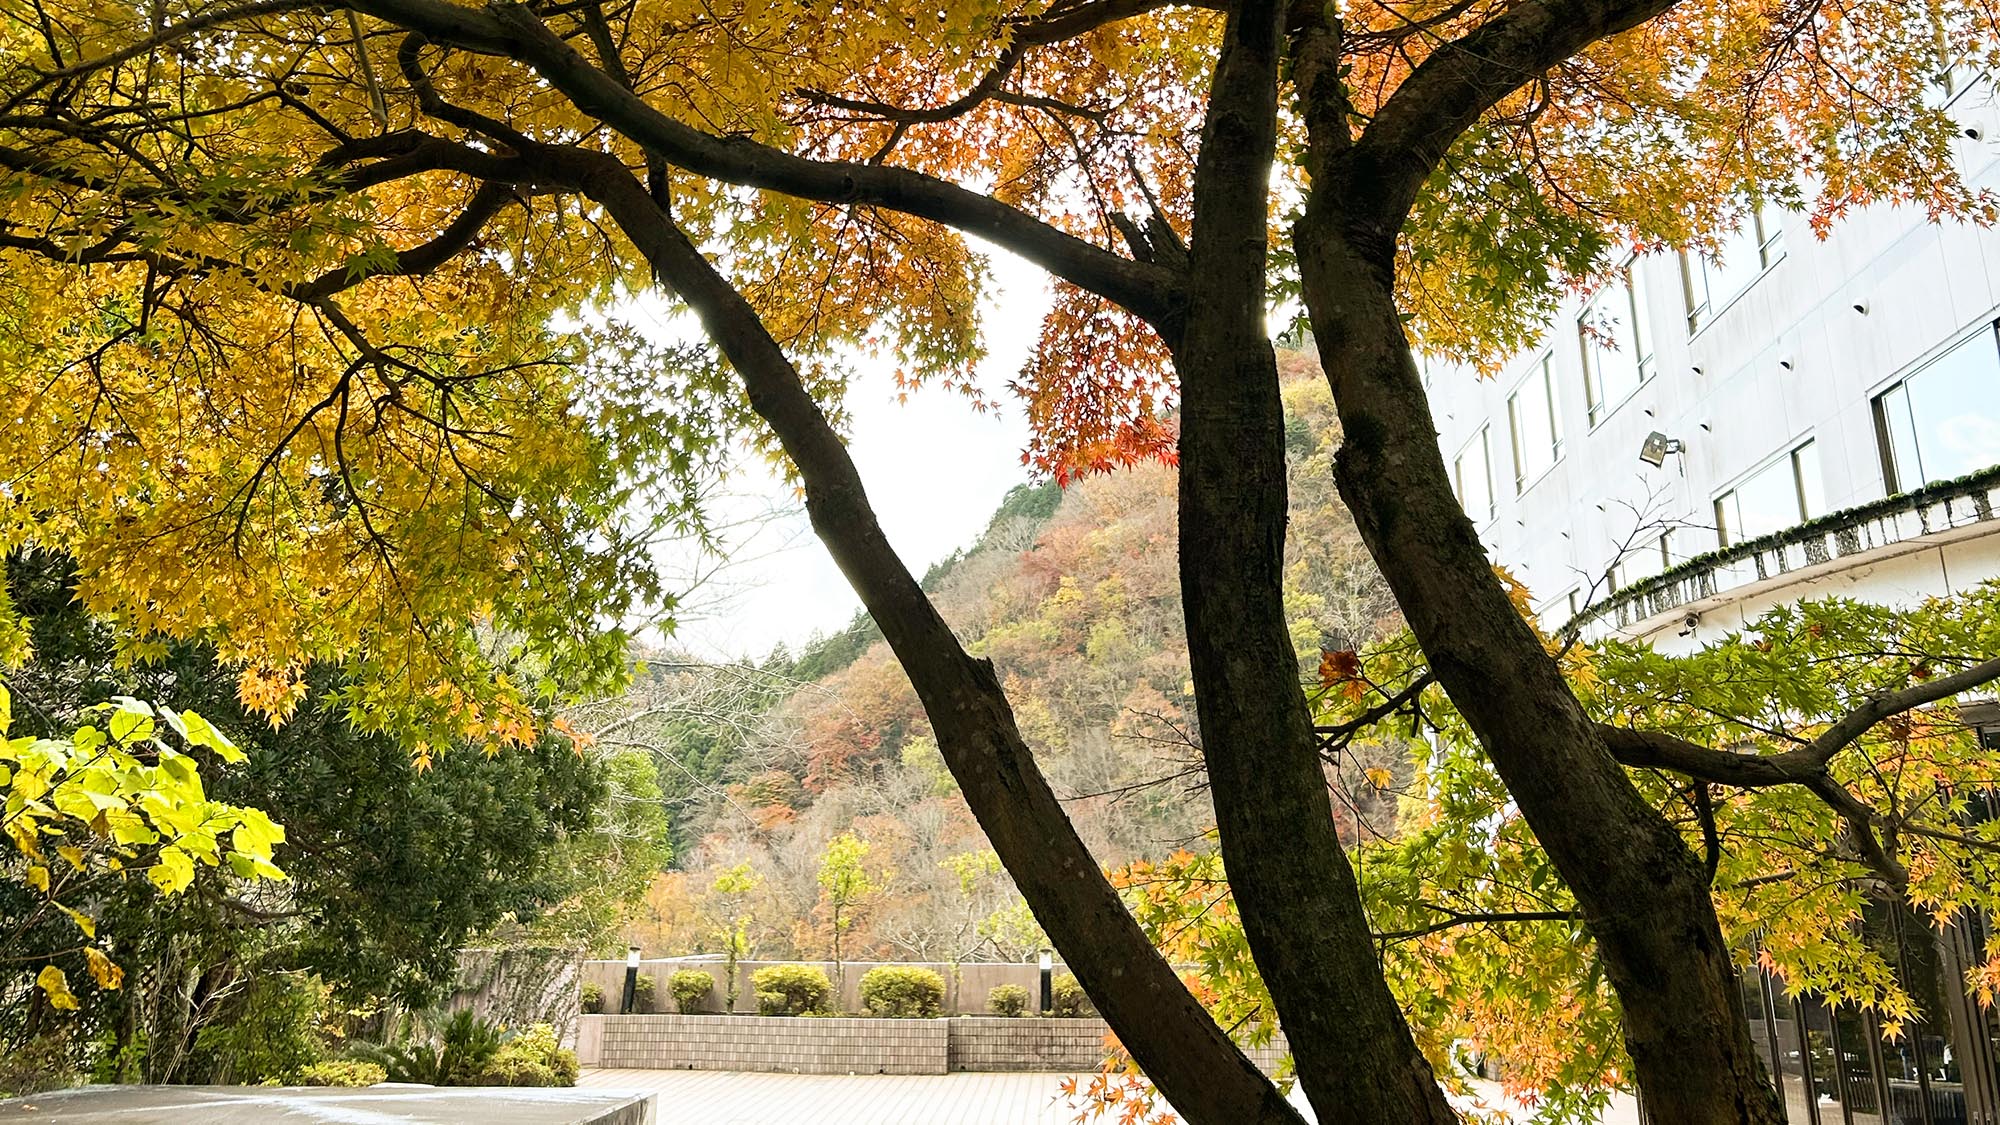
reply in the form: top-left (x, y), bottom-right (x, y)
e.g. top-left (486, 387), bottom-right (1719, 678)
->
top-left (576, 1015), bottom-right (1286, 1075)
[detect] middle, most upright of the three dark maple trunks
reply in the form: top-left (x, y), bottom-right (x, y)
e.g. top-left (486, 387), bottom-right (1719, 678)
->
top-left (1174, 2), bottom-right (1458, 1125)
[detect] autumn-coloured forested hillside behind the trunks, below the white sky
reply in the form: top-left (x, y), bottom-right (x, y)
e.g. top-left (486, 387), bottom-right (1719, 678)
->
top-left (608, 354), bottom-right (1402, 959)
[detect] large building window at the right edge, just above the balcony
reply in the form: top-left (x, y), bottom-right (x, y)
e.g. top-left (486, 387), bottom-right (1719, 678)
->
top-left (1874, 324), bottom-right (2000, 488)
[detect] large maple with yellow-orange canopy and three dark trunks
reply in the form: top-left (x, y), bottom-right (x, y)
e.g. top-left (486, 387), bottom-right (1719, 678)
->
top-left (0, 0), bottom-right (2000, 1121)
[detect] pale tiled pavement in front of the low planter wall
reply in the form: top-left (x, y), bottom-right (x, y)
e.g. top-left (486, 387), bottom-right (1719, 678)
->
top-left (578, 1069), bottom-right (1638, 1125)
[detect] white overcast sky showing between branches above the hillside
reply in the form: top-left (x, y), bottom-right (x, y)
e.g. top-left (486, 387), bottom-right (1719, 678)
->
top-left (642, 241), bottom-right (1050, 659)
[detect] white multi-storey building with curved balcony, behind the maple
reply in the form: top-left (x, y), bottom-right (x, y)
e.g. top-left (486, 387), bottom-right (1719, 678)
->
top-left (1426, 97), bottom-right (2000, 651)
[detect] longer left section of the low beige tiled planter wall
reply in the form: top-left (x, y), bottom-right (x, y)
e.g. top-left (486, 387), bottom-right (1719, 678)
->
top-left (578, 1015), bottom-right (950, 1075)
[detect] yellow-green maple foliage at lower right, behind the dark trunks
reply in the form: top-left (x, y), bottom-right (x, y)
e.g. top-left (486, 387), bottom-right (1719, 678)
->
top-left (1082, 583), bottom-right (2000, 1121)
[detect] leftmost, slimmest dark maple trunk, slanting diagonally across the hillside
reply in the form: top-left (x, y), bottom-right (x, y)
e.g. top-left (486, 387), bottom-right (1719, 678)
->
top-left (562, 164), bottom-right (1300, 1125)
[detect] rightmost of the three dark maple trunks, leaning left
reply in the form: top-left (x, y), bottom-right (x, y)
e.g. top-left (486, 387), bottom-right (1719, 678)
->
top-left (1294, 206), bottom-right (1784, 1125)
